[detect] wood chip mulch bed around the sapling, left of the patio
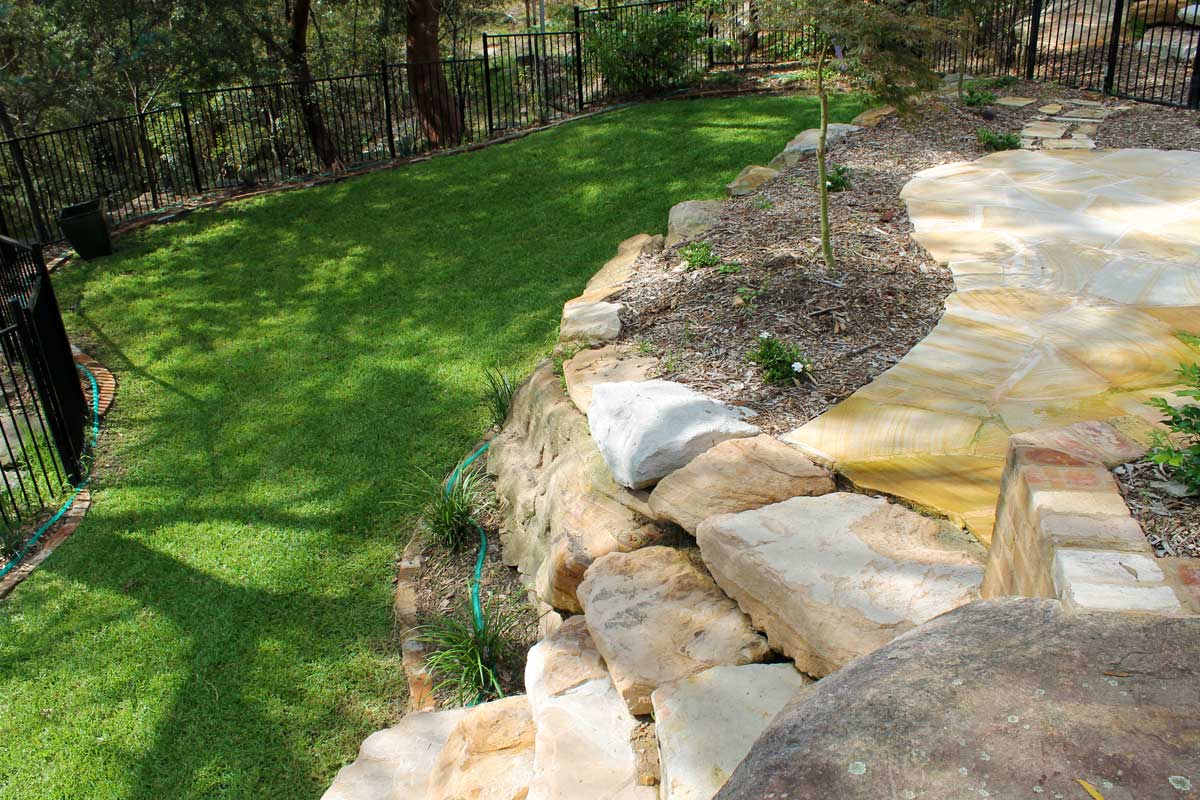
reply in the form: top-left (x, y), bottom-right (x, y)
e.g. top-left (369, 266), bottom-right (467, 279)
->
top-left (620, 82), bottom-right (1200, 433)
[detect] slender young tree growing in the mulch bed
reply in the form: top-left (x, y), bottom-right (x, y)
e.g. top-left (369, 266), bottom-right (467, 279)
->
top-left (773, 0), bottom-right (949, 272)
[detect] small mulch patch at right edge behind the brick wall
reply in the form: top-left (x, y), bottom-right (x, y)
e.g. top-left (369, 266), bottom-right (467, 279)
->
top-left (1114, 461), bottom-right (1200, 558)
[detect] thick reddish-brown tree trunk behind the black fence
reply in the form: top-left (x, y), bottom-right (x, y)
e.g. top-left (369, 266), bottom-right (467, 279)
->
top-left (404, 0), bottom-right (463, 148)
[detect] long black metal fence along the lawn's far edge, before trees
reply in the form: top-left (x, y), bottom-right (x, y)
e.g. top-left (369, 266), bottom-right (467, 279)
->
top-left (0, 0), bottom-right (820, 242)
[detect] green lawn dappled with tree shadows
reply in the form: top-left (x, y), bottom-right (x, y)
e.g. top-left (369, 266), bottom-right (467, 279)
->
top-left (0, 97), bottom-right (860, 800)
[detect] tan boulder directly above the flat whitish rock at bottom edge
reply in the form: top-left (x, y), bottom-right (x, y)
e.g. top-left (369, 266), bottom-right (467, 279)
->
top-left (578, 547), bottom-right (768, 715)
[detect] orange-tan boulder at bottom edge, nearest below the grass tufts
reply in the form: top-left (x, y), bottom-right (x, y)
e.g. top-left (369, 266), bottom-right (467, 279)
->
top-left (424, 696), bottom-right (534, 800)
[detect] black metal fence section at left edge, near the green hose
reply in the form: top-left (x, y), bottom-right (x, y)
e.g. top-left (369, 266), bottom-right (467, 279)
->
top-left (0, 236), bottom-right (86, 556)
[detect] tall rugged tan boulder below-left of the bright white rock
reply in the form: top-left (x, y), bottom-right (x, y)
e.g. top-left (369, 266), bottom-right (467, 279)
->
top-left (487, 362), bottom-right (661, 612)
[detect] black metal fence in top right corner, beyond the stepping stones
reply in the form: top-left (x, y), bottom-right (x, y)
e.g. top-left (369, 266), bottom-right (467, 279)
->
top-left (936, 0), bottom-right (1200, 109)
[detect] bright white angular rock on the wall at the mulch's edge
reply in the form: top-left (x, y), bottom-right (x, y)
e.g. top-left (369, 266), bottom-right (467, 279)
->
top-left (588, 380), bottom-right (758, 489)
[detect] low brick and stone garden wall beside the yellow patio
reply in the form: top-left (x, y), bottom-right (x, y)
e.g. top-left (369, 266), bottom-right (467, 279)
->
top-left (982, 422), bottom-right (1200, 615)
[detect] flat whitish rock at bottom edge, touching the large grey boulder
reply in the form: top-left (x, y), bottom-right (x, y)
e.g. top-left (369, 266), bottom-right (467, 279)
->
top-left (652, 664), bottom-right (812, 800)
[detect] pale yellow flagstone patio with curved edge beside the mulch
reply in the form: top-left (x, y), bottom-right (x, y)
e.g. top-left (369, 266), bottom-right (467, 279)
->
top-left (785, 150), bottom-right (1200, 543)
